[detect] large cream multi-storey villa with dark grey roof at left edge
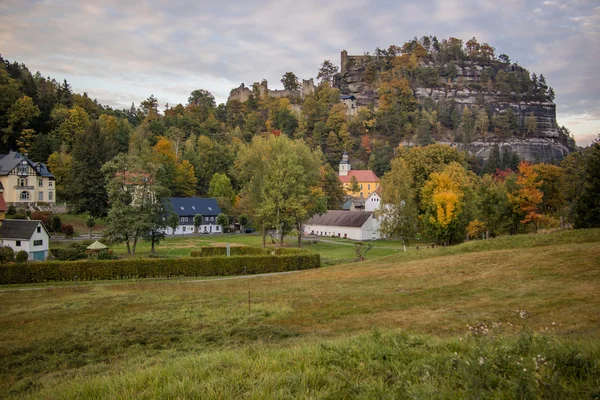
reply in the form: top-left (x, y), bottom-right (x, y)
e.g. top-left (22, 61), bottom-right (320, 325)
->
top-left (0, 151), bottom-right (56, 206)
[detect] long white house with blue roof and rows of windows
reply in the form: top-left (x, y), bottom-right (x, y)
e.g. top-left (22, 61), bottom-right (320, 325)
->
top-left (165, 197), bottom-right (222, 235)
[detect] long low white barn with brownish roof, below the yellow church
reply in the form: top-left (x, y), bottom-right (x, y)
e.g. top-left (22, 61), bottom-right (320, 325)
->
top-left (304, 210), bottom-right (381, 240)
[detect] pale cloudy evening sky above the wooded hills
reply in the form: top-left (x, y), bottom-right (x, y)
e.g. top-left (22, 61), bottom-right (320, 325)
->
top-left (0, 0), bottom-right (600, 145)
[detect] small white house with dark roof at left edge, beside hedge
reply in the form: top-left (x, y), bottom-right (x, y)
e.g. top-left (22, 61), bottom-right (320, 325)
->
top-left (0, 219), bottom-right (50, 261)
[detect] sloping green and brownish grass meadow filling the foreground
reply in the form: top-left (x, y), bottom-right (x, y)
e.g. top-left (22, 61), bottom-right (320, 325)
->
top-left (0, 230), bottom-right (600, 399)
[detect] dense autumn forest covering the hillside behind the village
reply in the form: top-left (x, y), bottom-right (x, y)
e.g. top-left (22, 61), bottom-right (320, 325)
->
top-left (0, 37), bottom-right (596, 245)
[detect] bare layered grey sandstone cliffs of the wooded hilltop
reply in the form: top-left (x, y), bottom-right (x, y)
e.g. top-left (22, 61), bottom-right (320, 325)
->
top-left (334, 46), bottom-right (574, 162)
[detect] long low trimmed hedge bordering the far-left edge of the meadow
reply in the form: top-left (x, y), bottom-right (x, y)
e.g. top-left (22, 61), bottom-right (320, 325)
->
top-left (0, 250), bottom-right (321, 284)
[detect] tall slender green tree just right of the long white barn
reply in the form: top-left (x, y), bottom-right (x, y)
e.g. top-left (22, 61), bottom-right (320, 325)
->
top-left (377, 158), bottom-right (419, 251)
